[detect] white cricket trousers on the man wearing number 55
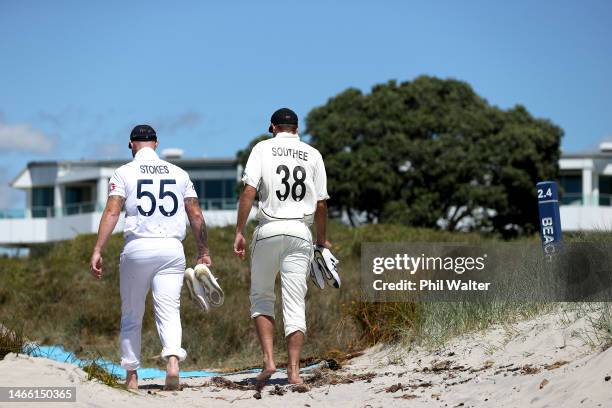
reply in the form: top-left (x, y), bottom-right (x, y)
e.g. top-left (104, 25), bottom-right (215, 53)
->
top-left (119, 238), bottom-right (187, 370)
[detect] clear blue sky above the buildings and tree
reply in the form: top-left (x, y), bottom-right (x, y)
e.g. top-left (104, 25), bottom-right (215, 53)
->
top-left (0, 0), bottom-right (612, 207)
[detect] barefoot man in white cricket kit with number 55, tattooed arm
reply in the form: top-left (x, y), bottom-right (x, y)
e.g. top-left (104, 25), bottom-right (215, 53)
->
top-left (90, 125), bottom-right (211, 389)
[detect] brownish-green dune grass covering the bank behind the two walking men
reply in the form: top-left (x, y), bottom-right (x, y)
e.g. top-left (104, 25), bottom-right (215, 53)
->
top-left (0, 223), bottom-right (609, 370)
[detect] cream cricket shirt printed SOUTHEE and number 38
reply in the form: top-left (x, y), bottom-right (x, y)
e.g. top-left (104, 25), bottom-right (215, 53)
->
top-left (242, 133), bottom-right (329, 224)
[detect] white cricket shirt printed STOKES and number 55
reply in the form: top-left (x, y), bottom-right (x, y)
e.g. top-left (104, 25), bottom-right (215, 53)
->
top-left (108, 147), bottom-right (198, 243)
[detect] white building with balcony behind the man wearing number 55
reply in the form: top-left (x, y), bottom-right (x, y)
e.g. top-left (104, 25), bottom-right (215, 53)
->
top-left (0, 151), bottom-right (240, 246)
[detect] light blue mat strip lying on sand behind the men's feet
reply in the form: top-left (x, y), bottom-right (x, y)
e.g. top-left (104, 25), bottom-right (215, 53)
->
top-left (28, 346), bottom-right (319, 380)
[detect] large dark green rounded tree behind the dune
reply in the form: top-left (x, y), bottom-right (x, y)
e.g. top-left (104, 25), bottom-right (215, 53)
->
top-left (306, 76), bottom-right (563, 236)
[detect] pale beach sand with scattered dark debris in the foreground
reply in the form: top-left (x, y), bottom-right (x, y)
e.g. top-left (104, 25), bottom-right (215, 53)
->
top-left (0, 314), bottom-right (612, 408)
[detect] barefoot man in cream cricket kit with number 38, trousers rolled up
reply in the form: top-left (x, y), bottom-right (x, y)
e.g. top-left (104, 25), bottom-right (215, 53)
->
top-left (234, 108), bottom-right (329, 384)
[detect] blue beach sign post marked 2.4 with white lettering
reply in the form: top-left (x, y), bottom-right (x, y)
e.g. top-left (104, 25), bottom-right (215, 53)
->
top-left (536, 181), bottom-right (562, 260)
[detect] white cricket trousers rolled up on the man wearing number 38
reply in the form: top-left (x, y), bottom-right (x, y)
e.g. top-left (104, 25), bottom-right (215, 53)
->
top-left (250, 221), bottom-right (313, 336)
